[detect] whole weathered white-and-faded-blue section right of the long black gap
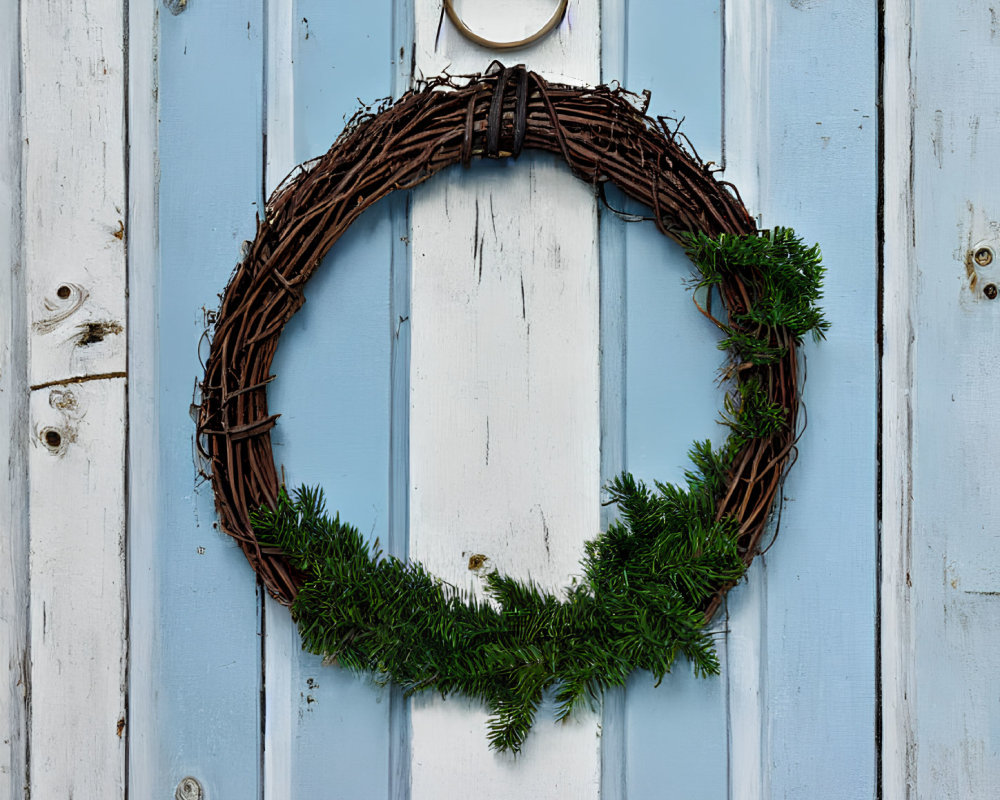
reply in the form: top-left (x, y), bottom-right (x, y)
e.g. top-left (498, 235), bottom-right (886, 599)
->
top-left (882, 0), bottom-right (1000, 798)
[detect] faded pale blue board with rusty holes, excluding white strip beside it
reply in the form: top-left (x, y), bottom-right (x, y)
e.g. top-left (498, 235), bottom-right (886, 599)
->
top-left (908, 0), bottom-right (1000, 800)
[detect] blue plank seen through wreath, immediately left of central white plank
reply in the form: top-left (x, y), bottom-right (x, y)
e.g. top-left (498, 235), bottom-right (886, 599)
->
top-left (269, 0), bottom-right (398, 798)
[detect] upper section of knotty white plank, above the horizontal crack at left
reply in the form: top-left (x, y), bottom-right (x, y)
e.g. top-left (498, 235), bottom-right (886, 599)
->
top-left (21, 0), bottom-right (125, 386)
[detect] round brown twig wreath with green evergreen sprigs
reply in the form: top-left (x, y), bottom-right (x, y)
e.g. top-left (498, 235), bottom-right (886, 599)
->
top-left (198, 65), bottom-right (827, 752)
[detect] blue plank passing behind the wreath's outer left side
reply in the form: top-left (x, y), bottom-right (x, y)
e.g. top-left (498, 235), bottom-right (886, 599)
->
top-left (152, 0), bottom-right (263, 798)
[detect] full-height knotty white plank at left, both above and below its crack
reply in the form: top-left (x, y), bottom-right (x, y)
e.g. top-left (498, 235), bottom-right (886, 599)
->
top-left (21, 0), bottom-right (126, 797)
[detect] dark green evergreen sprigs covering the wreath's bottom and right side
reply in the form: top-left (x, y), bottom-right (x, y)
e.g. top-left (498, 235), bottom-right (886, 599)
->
top-left (252, 229), bottom-right (828, 752)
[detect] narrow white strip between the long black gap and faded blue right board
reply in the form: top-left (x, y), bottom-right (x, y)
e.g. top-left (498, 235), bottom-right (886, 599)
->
top-left (879, 0), bottom-right (917, 798)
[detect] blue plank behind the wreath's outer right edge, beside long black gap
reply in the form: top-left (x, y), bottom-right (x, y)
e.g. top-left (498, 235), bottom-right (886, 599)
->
top-left (757, 0), bottom-right (878, 800)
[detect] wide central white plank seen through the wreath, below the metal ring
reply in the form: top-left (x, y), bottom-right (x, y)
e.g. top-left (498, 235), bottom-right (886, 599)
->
top-left (410, 2), bottom-right (600, 800)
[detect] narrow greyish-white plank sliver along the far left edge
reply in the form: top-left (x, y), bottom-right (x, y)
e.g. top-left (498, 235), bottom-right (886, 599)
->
top-left (0, 3), bottom-right (28, 800)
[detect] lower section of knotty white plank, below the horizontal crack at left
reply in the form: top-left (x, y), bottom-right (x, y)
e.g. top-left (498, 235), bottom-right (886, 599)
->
top-left (28, 378), bottom-right (126, 797)
